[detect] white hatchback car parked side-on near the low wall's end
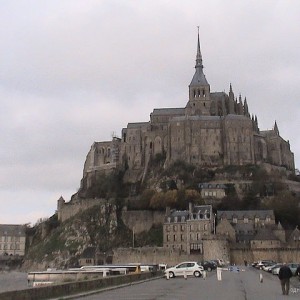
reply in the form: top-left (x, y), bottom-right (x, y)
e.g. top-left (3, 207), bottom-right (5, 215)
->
top-left (165, 261), bottom-right (204, 278)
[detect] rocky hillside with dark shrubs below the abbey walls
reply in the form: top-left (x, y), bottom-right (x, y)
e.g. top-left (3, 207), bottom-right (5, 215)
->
top-left (24, 161), bottom-right (300, 269)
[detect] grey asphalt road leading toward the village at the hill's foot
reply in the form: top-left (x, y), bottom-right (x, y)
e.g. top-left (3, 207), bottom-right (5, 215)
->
top-left (71, 267), bottom-right (300, 300)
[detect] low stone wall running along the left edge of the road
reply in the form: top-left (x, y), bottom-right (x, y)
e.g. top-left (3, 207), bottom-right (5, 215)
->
top-left (0, 272), bottom-right (162, 300)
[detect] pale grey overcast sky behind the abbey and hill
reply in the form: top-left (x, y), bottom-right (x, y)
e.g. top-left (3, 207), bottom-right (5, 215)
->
top-left (0, 0), bottom-right (300, 225)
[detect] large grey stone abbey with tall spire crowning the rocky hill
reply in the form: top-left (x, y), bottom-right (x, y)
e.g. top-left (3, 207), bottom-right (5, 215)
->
top-left (82, 33), bottom-right (294, 187)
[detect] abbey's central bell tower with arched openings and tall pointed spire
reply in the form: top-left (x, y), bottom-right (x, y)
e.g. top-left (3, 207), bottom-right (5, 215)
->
top-left (185, 27), bottom-right (211, 116)
